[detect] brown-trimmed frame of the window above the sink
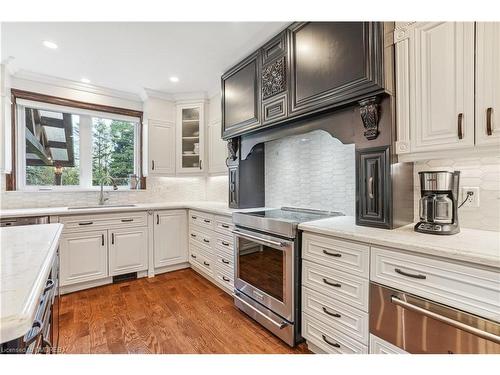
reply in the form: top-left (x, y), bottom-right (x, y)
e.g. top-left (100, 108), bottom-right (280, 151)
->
top-left (6, 89), bottom-right (146, 192)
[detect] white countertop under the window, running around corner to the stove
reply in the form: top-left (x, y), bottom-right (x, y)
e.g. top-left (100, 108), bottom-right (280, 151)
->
top-left (0, 201), bottom-right (243, 217)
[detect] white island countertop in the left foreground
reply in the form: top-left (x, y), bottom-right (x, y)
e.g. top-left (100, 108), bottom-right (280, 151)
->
top-left (0, 224), bottom-right (63, 343)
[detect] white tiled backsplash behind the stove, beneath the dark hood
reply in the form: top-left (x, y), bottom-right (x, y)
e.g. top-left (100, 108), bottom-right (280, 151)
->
top-left (265, 130), bottom-right (355, 215)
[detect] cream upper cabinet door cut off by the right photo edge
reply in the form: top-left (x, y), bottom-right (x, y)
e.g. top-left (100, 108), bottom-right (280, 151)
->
top-left (476, 22), bottom-right (500, 145)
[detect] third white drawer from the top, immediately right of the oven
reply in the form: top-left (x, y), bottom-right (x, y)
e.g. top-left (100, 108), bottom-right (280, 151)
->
top-left (302, 287), bottom-right (369, 345)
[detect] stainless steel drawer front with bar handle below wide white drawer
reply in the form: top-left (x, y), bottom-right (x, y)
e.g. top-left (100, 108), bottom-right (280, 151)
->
top-left (370, 283), bottom-right (500, 354)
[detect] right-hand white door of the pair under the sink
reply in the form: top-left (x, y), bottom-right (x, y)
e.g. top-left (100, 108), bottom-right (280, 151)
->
top-left (109, 228), bottom-right (148, 276)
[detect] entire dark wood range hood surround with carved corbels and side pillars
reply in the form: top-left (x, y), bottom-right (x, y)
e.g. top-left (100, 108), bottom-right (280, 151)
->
top-left (222, 22), bottom-right (413, 228)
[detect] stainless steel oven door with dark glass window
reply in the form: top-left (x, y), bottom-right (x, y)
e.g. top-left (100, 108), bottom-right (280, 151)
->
top-left (233, 228), bottom-right (295, 322)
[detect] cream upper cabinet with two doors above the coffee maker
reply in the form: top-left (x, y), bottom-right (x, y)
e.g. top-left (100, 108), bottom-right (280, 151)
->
top-left (394, 22), bottom-right (500, 159)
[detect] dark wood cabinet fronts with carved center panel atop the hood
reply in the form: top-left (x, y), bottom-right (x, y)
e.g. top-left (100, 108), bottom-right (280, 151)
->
top-left (222, 22), bottom-right (393, 139)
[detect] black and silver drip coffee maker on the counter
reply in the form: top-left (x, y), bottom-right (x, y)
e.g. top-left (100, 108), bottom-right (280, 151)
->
top-left (415, 171), bottom-right (460, 234)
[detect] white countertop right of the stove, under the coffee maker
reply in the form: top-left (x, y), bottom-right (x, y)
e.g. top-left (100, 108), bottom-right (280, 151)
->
top-left (299, 216), bottom-right (500, 268)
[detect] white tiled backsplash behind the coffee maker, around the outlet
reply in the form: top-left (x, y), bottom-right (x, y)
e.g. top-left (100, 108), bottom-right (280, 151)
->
top-left (414, 156), bottom-right (500, 231)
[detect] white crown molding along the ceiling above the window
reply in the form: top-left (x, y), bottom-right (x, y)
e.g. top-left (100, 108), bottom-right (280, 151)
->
top-left (12, 70), bottom-right (142, 103)
